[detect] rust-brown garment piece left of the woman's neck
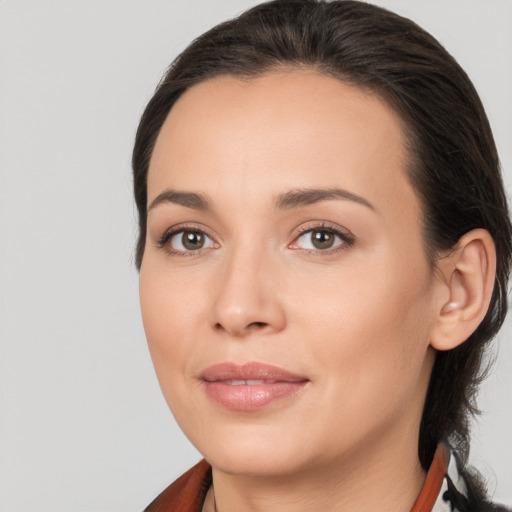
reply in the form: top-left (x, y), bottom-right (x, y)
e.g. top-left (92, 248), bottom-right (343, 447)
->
top-left (144, 459), bottom-right (212, 512)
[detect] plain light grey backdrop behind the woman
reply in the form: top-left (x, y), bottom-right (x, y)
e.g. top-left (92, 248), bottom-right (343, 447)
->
top-left (0, 0), bottom-right (512, 512)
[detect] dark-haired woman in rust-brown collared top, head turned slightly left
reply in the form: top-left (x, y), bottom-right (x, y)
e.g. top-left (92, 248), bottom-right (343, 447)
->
top-left (133, 0), bottom-right (511, 512)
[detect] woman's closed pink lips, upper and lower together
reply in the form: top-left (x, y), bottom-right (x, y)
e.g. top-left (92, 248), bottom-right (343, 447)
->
top-left (199, 362), bottom-right (309, 411)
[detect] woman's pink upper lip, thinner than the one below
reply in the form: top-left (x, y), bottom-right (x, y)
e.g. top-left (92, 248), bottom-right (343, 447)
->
top-left (199, 362), bottom-right (308, 382)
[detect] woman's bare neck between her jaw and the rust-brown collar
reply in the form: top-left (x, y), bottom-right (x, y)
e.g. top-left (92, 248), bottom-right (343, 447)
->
top-left (213, 428), bottom-right (426, 512)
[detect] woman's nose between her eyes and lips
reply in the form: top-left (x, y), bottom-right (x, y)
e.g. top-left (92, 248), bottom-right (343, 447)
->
top-left (211, 249), bottom-right (286, 337)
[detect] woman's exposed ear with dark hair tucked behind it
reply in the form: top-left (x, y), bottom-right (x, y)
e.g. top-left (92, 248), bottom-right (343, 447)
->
top-left (430, 229), bottom-right (496, 350)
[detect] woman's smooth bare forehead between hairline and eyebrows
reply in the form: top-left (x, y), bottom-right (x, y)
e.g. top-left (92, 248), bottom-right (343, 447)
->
top-left (148, 70), bottom-right (416, 220)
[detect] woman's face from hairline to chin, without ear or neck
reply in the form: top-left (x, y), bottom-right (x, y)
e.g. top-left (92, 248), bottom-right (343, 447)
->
top-left (140, 71), bottom-right (436, 475)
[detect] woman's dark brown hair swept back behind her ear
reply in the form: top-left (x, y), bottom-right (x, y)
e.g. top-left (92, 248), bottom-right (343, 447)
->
top-left (133, 0), bottom-right (512, 504)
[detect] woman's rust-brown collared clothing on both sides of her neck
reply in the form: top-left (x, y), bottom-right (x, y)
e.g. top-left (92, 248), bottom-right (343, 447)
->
top-left (144, 444), bottom-right (466, 512)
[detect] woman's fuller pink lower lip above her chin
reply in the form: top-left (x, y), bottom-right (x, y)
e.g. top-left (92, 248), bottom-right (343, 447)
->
top-left (205, 381), bottom-right (307, 411)
